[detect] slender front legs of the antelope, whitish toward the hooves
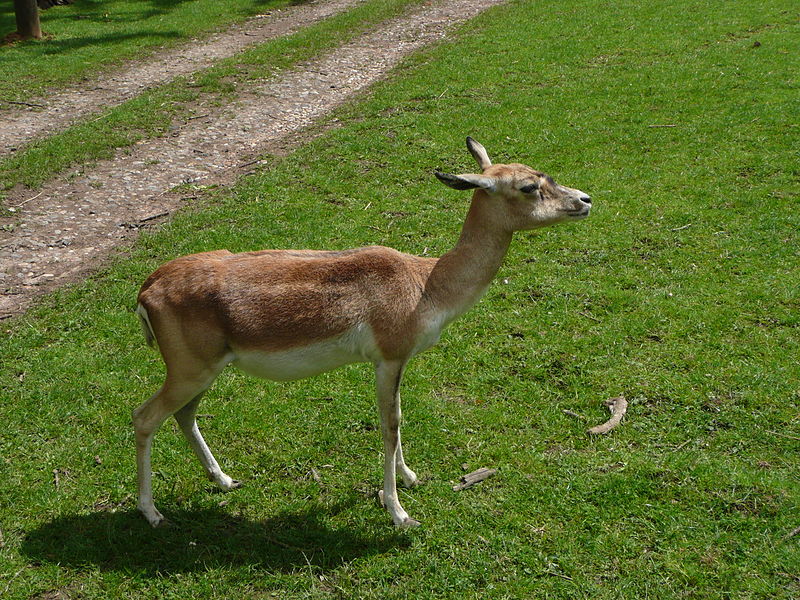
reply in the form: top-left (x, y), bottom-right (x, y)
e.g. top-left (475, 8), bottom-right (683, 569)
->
top-left (375, 361), bottom-right (419, 527)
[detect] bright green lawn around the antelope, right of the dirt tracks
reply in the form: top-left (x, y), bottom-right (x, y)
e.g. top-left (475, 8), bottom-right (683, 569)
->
top-left (0, 0), bottom-right (800, 600)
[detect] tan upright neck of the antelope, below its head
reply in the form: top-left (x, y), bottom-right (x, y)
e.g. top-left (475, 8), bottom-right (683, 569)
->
top-left (426, 190), bottom-right (512, 318)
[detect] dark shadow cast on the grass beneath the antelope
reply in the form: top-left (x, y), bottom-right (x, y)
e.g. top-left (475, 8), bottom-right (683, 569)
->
top-left (21, 506), bottom-right (409, 576)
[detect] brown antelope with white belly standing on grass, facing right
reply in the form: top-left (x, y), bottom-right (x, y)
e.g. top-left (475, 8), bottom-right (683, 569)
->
top-left (133, 138), bottom-right (591, 527)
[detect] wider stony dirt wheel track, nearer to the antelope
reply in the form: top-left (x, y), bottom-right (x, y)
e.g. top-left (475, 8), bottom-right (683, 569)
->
top-left (0, 0), bottom-right (505, 318)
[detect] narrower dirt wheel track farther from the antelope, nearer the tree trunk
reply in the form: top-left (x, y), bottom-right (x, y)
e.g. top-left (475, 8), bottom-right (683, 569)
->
top-left (0, 0), bottom-right (364, 156)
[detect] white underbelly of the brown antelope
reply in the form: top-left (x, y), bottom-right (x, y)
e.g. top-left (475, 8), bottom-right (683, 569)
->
top-left (232, 328), bottom-right (377, 381)
